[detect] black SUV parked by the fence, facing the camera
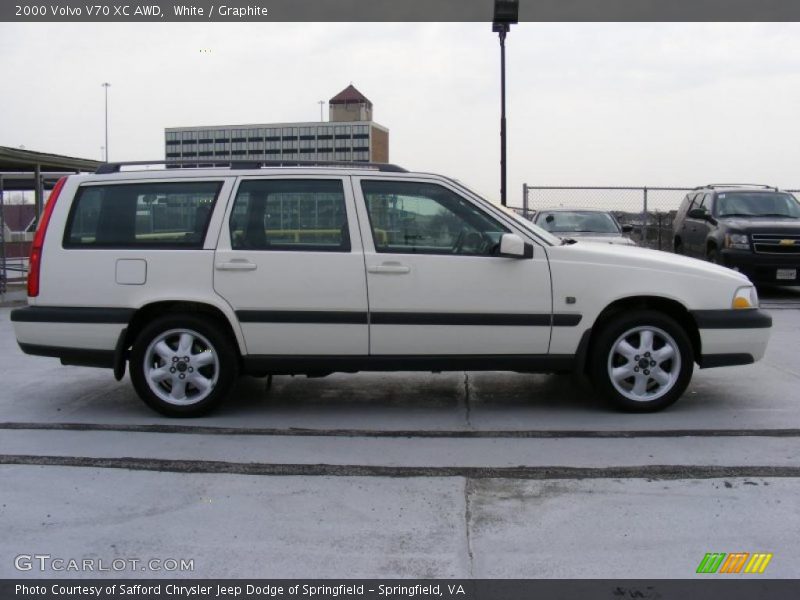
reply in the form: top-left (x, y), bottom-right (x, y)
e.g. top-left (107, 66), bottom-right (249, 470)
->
top-left (672, 184), bottom-right (800, 285)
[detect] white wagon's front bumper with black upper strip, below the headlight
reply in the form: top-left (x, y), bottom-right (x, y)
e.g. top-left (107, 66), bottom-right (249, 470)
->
top-left (692, 309), bottom-right (772, 369)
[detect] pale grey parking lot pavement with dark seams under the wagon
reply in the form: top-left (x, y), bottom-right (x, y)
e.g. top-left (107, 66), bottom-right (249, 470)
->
top-left (0, 290), bottom-right (800, 578)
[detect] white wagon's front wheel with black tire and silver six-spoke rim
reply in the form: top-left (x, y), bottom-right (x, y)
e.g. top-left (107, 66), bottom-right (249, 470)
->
top-left (589, 310), bottom-right (694, 413)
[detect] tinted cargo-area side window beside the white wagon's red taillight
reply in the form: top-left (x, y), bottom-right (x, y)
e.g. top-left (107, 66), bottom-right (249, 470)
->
top-left (64, 181), bottom-right (222, 249)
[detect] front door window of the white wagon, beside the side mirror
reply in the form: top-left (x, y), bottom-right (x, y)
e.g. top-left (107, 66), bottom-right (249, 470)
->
top-left (361, 181), bottom-right (508, 256)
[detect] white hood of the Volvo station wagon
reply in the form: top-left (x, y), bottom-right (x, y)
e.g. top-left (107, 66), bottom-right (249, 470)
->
top-left (551, 240), bottom-right (750, 284)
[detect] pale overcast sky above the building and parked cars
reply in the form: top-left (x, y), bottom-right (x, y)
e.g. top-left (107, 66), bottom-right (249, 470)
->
top-left (0, 23), bottom-right (800, 205)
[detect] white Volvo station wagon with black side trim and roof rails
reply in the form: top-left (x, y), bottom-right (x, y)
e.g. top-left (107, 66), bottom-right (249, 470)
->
top-left (11, 163), bottom-right (772, 417)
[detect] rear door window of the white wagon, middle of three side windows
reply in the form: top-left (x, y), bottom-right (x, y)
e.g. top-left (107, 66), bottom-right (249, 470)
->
top-left (229, 179), bottom-right (350, 252)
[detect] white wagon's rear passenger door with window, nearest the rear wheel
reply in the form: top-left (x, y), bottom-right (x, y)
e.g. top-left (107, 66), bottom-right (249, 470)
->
top-left (214, 175), bottom-right (368, 356)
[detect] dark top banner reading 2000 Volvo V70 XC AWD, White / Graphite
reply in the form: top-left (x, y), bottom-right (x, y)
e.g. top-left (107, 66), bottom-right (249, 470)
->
top-left (0, 0), bottom-right (800, 22)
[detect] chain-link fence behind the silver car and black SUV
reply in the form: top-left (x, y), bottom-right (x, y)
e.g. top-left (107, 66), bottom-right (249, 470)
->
top-left (510, 184), bottom-right (800, 252)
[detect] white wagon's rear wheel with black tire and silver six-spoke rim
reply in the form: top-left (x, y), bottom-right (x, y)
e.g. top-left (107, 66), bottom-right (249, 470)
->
top-left (130, 314), bottom-right (238, 417)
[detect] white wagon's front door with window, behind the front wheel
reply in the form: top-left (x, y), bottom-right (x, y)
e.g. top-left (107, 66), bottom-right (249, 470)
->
top-left (353, 177), bottom-right (552, 356)
